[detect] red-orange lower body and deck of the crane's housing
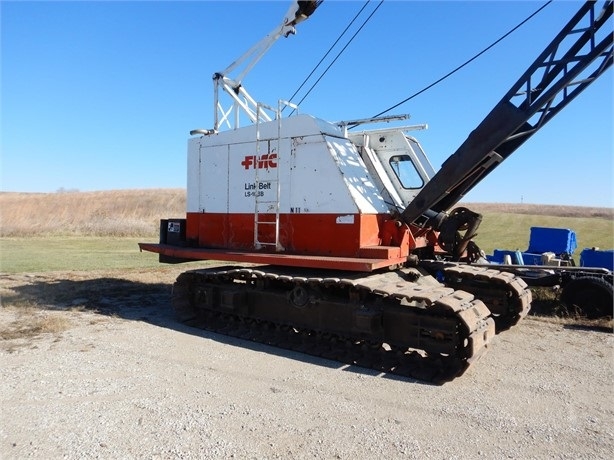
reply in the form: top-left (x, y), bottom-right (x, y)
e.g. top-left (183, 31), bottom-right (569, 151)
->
top-left (140, 213), bottom-right (436, 271)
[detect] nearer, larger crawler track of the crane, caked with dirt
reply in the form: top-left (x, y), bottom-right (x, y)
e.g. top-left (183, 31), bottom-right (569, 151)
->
top-left (173, 267), bottom-right (495, 384)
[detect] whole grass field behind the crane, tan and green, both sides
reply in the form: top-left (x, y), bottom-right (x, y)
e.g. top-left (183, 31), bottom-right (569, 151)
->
top-left (0, 189), bottom-right (614, 273)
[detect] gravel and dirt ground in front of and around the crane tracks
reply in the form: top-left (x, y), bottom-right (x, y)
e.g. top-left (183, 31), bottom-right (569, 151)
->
top-left (0, 268), bottom-right (614, 459)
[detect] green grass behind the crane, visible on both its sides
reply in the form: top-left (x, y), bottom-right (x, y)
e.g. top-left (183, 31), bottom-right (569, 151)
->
top-left (0, 213), bottom-right (614, 273)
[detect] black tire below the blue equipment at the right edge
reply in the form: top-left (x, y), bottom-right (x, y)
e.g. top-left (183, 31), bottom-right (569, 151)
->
top-left (561, 276), bottom-right (614, 319)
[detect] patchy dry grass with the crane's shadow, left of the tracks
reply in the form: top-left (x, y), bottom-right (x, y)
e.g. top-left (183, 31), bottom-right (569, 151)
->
top-left (0, 267), bottom-right (180, 342)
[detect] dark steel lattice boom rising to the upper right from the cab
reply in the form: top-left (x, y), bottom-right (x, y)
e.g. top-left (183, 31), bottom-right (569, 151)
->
top-left (402, 0), bottom-right (614, 225)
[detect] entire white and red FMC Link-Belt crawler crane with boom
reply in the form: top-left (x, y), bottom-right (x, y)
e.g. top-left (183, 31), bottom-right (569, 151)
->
top-left (140, 1), bottom-right (613, 383)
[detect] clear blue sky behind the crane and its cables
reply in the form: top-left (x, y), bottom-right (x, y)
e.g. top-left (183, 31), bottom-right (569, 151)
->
top-left (0, 0), bottom-right (614, 207)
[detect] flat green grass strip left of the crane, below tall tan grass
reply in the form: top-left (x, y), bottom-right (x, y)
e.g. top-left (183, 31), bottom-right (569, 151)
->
top-left (0, 236), bottom-right (160, 273)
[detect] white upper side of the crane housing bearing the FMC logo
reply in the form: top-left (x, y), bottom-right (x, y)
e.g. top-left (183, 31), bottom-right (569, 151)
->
top-left (188, 116), bottom-right (388, 215)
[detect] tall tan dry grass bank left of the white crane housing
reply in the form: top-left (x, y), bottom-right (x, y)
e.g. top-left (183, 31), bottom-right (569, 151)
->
top-left (0, 189), bottom-right (185, 237)
